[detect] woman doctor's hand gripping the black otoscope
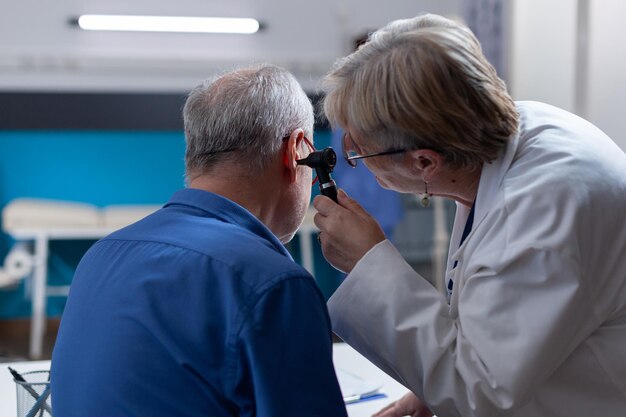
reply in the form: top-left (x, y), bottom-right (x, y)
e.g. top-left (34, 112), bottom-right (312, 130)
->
top-left (313, 190), bottom-right (385, 273)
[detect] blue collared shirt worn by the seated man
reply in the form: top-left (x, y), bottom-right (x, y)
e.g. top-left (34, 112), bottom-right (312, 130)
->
top-left (51, 189), bottom-right (346, 417)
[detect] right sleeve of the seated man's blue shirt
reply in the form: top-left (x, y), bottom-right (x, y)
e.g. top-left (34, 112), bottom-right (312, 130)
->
top-left (236, 277), bottom-right (347, 417)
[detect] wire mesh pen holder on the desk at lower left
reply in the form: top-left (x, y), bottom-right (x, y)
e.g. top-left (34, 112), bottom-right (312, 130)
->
top-left (13, 371), bottom-right (52, 417)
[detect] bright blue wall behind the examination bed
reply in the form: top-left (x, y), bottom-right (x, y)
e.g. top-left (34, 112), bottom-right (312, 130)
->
top-left (0, 131), bottom-right (336, 318)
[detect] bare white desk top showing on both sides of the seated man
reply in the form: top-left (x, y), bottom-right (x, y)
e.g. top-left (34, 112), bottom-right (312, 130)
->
top-left (0, 343), bottom-right (407, 417)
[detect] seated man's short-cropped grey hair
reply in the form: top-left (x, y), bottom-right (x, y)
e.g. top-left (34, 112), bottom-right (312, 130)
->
top-left (183, 65), bottom-right (314, 176)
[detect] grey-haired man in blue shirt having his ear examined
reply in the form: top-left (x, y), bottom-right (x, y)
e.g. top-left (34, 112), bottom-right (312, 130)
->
top-left (52, 66), bottom-right (346, 417)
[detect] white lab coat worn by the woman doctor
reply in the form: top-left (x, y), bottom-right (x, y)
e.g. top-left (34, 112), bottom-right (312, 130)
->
top-left (328, 102), bottom-right (626, 417)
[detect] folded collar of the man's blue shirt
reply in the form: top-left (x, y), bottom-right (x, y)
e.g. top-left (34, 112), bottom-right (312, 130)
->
top-left (164, 188), bottom-right (292, 259)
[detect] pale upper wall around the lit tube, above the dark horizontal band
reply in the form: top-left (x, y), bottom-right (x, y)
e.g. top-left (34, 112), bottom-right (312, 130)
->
top-left (0, 0), bottom-right (462, 91)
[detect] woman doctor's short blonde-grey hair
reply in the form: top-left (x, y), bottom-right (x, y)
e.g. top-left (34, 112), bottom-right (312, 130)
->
top-left (322, 15), bottom-right (519, 168)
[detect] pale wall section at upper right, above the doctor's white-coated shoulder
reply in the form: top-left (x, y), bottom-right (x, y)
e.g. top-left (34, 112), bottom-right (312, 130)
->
top-left (508, 0), bottom-right (626, 151)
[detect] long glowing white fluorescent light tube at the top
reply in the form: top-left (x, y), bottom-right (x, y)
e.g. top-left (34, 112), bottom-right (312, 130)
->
top-left (78, 14), bottom-right (260, 34)
